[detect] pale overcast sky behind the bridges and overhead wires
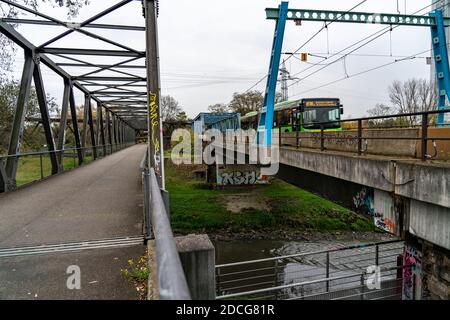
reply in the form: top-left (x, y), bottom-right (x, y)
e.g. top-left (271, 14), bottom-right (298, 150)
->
top-left (7, 0), bottom-right (431, 117)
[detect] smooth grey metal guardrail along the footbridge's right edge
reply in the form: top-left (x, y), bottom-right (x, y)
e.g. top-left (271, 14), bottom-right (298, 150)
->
top-left (140, 152), bottom-right (191, 300)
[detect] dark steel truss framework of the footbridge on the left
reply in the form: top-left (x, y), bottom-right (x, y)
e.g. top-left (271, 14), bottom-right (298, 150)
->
top-left (0, 0), bottom-right (159, 192)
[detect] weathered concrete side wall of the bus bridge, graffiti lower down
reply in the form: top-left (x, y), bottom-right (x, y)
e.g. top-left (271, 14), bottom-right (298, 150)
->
top-left (280, 148), bottom-right (450, 249)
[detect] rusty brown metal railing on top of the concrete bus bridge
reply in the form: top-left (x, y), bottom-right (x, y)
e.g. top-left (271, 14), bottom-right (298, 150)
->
top-left (278, 109), bottom-right (450, 161)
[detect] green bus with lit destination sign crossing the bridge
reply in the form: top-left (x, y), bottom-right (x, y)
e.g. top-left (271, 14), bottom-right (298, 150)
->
top-left (241, 98), bottom-right (344, 132)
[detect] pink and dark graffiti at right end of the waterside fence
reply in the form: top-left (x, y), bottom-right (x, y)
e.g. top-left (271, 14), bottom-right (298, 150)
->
top-left (403, 244), bottom-right (422, 300)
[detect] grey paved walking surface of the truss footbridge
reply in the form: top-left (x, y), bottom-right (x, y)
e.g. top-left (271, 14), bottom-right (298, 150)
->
top-left (0, 145), bottom-right (146, 299)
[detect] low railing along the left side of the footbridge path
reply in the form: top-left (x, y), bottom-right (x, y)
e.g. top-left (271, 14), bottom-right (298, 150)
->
top-left (0, 143), bottom-right (134, 187)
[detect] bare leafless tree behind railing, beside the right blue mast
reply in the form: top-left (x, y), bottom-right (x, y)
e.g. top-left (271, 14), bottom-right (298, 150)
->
top-left (389, 79), bottom-right (437, 125)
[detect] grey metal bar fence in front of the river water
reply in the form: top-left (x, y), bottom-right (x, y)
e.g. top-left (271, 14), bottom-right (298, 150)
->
top-left (216, 240), bottom-right (403, 300)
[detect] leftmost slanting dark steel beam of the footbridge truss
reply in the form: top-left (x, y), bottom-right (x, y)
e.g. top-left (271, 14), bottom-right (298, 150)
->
top-left (5, 50), bottom-right (35, 191)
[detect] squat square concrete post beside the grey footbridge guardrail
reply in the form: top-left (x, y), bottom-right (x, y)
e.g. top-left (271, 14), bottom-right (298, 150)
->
top-left (175, 234), bottom-right (216, 300)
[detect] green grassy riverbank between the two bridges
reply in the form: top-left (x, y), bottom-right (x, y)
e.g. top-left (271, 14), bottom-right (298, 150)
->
top-left (166, 161), bottom-right (375, 233)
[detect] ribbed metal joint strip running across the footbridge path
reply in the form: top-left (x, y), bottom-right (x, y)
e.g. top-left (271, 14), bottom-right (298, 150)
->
top-left (0, 236), bottom-right (144, 258)
